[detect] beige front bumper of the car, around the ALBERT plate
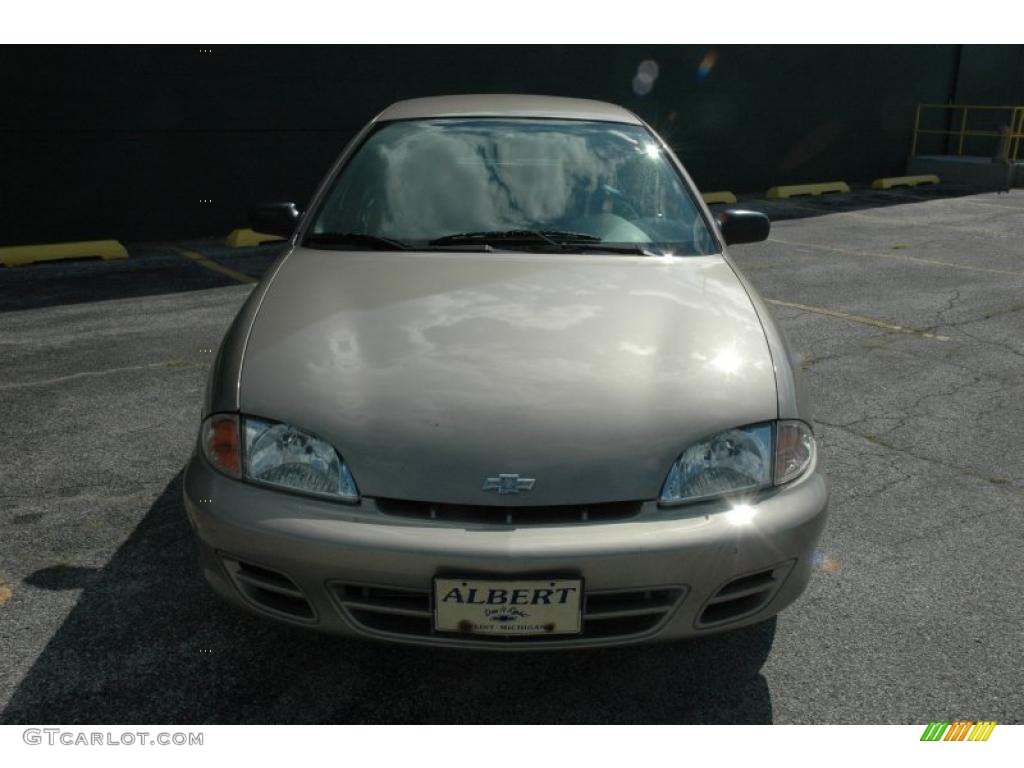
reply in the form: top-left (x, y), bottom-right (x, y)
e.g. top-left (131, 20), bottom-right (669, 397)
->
top-left (183, 455), bottom-right (828, 649)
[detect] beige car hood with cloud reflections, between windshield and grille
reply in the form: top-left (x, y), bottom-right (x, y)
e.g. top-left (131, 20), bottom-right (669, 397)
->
top-left (239, 249), bottom-right (777, 505)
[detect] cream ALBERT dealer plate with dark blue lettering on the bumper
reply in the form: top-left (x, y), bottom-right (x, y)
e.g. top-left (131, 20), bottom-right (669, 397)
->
top-left (434, 579), bottom-right (583, 635)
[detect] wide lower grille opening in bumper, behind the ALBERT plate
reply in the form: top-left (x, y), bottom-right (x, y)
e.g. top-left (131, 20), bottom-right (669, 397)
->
top-left (330, 583), bottom-right (684, 645)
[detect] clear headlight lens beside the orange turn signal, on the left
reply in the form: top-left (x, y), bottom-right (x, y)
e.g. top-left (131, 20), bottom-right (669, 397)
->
top-left (243, 416), bottom-right (359, 502)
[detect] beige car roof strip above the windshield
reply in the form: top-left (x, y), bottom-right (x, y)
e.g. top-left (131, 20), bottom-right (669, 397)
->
top-left (376, 93), bottom-right (641, 125)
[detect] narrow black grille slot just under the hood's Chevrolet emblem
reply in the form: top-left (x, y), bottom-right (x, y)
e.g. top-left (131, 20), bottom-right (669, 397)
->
top-left (375, 499), bottom-right (643, 525)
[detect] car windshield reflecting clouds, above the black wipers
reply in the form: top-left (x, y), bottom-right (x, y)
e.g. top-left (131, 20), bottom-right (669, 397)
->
top-left (306, 118), bottom-right (718, 255)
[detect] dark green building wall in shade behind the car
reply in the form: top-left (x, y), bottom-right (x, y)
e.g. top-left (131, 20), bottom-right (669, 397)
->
top-left (0, 44), bottom-right (1007, 244)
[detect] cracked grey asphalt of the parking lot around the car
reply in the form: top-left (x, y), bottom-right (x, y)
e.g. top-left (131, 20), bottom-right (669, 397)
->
top-left (0, 186), bottom-right (1024, 723)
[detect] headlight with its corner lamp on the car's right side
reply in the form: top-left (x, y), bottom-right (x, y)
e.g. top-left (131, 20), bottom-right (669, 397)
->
top-left (659, 421), bottom-right (815, 504)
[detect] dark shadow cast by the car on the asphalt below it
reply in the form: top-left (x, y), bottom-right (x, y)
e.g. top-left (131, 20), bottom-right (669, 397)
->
top-left (0, 474), bottom-right (775, 724)
